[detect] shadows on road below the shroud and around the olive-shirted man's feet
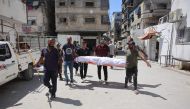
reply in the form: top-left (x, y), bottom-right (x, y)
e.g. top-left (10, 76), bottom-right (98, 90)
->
top-left (70, 80), bottom-right (167, 100)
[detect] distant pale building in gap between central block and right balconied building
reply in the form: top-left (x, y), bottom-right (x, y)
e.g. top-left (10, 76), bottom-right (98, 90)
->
top-left (111, 12), bottom-right (122, 41)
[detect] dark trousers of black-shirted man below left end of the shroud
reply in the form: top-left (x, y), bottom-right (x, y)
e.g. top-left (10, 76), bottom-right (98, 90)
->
top-left (80, 63), bottom-right (88, 79)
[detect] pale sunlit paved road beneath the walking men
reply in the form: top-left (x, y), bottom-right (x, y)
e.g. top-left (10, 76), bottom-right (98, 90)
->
top-left (0, 56), bottom-right (190, 109)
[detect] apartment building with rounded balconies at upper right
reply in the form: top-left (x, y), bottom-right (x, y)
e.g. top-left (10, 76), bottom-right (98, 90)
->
top-left (122, 0), bottom-right (171, 36)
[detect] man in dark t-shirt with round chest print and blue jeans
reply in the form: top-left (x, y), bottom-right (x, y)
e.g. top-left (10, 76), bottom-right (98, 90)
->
top-left (63, 37), bottom-right (76, 85)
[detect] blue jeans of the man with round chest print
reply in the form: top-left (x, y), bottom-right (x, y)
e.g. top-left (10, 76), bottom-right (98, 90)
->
top-left (64, 61), bottom-right (73, 82)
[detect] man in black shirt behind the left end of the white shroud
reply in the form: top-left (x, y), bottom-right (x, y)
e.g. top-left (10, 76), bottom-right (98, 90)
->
top-left (77, 41), bottom-right (90, 80)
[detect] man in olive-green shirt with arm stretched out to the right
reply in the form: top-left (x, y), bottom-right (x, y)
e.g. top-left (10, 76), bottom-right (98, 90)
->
top-left (125, 41), bottom-right (151, 94)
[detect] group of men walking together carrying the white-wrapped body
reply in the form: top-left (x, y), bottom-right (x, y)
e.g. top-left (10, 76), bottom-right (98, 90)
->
top-left (36, 37), bottom-right (150, 98)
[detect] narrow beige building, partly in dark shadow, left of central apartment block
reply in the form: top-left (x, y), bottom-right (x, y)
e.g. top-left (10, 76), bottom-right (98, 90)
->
top-left (26, 0), bottom-right (55, 35)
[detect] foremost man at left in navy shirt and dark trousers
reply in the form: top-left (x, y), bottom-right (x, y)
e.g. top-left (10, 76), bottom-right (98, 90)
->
top-left (36, 39), bottom-right (60, 98)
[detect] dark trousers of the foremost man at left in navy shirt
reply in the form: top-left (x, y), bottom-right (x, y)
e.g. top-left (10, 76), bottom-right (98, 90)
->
top-left (44, 71), bottom-right (57, 95)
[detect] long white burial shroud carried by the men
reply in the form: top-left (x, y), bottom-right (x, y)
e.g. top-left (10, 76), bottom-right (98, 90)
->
top-left (75, 56), bottom-right (126, 67)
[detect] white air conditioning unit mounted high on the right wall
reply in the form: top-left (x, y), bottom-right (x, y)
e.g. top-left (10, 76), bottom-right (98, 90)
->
top-left (169, 9), bottom-right (183, 23)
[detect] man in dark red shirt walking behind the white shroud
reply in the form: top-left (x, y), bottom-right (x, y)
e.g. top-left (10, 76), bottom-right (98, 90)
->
top-left (95, 40), bottom-right (110, 84)
